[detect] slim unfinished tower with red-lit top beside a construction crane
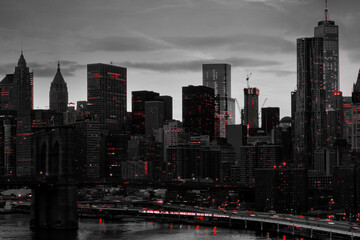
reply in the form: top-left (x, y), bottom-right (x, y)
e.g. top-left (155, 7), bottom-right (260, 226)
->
top-left (243, 88), bottom-right (260, 128)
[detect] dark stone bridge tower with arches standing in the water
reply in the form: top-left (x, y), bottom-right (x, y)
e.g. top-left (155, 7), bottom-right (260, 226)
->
top-left (30, 126), bottom-right (78, 229)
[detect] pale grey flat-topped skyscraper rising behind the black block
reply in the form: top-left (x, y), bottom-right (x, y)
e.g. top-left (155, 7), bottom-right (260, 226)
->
top-left (203, 63), bottom-right (235, 138)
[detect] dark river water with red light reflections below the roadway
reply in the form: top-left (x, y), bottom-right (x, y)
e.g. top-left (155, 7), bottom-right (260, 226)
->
top-left (0, 214), bottom-right (300, 240)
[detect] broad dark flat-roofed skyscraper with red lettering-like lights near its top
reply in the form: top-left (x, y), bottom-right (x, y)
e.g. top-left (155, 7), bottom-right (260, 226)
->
top-left (87, 63), bottom-right (127, 130)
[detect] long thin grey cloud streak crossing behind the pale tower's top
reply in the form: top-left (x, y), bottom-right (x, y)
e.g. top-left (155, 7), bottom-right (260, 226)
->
top-left (118, 58), bottom-right (280, 72)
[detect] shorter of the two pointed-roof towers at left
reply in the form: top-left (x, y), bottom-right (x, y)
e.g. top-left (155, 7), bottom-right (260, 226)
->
top-left (49, 63), bottom-right (68, 113)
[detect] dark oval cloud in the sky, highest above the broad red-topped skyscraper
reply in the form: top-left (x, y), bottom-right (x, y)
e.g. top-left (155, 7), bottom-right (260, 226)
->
top-left (81, 36), bottom-right (170, 52)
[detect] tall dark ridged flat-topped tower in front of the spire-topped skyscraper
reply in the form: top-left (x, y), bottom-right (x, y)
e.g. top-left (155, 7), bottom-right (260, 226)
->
top-left (294, 38), bottom-right (326, 170)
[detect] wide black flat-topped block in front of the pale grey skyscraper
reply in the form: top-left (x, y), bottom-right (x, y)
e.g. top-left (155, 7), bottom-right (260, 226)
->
top-left (182, 85), bottom-right (215, 138)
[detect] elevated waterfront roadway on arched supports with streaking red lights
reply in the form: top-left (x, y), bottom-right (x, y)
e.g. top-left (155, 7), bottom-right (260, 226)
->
top-left (78, 205), bottom-right (360, 239)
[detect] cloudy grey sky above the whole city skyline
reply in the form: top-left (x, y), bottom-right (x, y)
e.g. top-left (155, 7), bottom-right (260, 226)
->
top-left (0, 0), bottom-right (360, 122)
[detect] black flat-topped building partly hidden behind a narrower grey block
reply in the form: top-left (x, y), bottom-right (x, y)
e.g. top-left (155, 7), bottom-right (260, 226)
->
top-left (131, 91), bottom-right (160, 135)
